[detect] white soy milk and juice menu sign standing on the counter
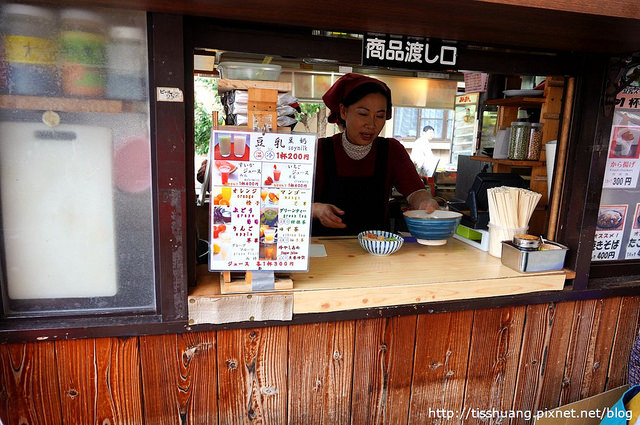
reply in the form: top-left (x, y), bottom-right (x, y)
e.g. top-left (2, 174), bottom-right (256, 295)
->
top-left (209, 130), bottom-right (316, 271)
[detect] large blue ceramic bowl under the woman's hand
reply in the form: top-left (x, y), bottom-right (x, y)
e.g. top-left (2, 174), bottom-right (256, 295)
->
top-left (404, 210), bottom-right (462, 245)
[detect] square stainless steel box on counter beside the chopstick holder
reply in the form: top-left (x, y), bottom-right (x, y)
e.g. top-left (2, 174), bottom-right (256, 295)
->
top-left (501, 241), bottom-right (568, 272)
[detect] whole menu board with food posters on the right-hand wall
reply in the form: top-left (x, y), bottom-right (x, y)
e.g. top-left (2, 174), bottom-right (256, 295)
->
top-left (591, 78), bottom-right (640, 261)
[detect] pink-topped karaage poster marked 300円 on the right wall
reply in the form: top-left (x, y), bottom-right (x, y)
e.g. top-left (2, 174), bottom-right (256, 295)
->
top-left (602, 125), bottom-right (640, 189)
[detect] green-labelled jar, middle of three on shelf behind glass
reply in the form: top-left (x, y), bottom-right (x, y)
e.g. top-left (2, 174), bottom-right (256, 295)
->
top-left (59, 9), bottom-right (107, 97)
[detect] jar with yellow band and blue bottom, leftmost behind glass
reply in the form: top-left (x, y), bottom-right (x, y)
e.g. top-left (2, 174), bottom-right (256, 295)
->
top-left (2, 3), bottom-right (60, 96)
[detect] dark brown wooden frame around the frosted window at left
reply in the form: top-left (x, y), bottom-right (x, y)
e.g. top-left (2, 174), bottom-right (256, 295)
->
top-left (0, 13), bottom-right (193, 342)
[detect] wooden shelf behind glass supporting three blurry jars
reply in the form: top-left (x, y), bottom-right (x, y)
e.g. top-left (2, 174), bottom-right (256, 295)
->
top-left (0, 95), bottom-right (147, 114)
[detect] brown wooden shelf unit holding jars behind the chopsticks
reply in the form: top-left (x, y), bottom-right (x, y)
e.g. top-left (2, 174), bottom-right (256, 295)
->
top-left (471, 76), bottom-right (564, 235)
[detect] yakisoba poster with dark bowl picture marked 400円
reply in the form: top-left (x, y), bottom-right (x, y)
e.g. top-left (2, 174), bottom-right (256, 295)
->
top-left (591, 205), bottom-right (628, 261)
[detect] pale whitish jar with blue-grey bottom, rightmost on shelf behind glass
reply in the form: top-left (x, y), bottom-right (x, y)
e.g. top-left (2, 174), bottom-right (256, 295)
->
top-left (105, 26), bottom-right (147, 100)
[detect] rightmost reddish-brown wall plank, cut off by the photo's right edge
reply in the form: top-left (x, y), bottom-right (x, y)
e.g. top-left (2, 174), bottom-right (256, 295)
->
top-left (606, 297), bottom-right (640, 390)
